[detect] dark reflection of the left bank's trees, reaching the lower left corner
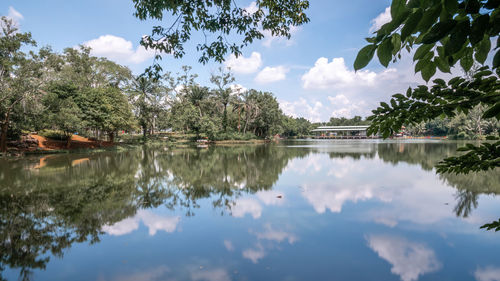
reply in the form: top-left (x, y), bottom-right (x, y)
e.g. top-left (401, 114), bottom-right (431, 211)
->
top-left (0, 152), bottom-right (140, 280)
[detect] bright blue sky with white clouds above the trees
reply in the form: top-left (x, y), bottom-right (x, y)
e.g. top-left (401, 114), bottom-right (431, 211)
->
top-left (0, 0), bottom-right (434, 121)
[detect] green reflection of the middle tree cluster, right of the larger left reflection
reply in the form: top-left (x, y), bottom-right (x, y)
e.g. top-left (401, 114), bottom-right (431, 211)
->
top-left (157, 146), bottom-right (308, 215)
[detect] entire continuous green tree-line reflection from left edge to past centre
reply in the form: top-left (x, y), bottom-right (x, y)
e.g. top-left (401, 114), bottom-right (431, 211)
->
top-left (0, 146), bottom-right (308, 280)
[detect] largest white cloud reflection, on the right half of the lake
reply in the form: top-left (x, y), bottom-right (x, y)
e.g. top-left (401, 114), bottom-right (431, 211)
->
top-left (296, 158), bottom-right (455, 227)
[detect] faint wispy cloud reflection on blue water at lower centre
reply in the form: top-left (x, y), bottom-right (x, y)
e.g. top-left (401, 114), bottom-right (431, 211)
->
top-left (242, 224), bottom-right (298, 263)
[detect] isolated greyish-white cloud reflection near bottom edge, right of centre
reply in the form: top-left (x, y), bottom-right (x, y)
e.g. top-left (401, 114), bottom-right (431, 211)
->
top-left (367, 235), bottom-right (441, 281)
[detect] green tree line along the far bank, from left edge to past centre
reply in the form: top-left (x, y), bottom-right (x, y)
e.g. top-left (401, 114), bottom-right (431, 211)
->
top-left (0, 17), bottom-right (311, 151)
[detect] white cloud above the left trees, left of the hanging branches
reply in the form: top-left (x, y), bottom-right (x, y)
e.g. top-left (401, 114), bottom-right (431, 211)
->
top-left (83, 35), bottom-right (154, 64)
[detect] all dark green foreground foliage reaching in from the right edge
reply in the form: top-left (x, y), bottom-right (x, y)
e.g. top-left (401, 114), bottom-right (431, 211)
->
top-left (354, 0), bottom-right (500, 230)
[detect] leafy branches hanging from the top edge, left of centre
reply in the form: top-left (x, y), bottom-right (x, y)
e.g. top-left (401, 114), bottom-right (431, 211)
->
top-left (133, 0), bottom-right (309, 70)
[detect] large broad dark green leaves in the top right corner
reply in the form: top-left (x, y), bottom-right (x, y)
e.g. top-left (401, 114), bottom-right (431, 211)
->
top-left (354, 0), bottom-right (500, 81)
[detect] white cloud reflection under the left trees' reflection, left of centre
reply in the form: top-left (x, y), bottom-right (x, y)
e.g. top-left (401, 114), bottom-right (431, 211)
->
top-left (102, 210), bottom-right (181, 236)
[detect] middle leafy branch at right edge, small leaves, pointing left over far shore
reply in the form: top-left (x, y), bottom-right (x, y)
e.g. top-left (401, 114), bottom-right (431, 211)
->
top-left (368, 67), bottom-right (500, 138)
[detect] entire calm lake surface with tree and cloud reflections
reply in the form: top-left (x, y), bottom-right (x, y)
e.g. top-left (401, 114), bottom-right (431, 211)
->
top-left (0, 140), bottom-right (500, 281)
